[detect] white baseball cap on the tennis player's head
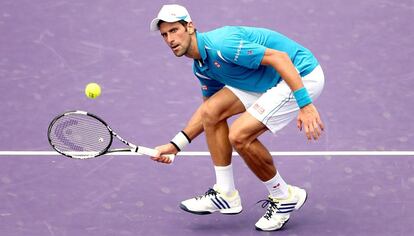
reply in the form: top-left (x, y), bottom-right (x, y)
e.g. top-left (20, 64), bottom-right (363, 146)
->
top-left (150, 4), bottom-right (191, 31)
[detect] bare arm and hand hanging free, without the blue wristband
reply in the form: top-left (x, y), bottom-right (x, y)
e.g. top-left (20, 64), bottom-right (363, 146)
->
top-left (261, 48), bottom-right (324, 140)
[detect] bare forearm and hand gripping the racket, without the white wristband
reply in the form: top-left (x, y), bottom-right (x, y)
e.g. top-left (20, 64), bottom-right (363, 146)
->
top-left (151, 97), bottom-right (208, 164)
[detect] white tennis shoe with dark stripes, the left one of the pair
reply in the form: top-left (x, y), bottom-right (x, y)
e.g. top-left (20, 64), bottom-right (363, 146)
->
top-left (180, 185), bottom-right (243, 215)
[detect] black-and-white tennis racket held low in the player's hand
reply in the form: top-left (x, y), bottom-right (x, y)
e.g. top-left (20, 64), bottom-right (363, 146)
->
top-left (48, 111), bottom-right (175, 161)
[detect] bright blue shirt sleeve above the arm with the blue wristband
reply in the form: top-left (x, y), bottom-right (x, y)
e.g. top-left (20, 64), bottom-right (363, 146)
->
top-left (220, 35), bottom-right (266, 69)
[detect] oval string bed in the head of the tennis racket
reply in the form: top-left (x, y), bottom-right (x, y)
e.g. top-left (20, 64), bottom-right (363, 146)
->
top-left (49, 113), bottom-right (112, 158)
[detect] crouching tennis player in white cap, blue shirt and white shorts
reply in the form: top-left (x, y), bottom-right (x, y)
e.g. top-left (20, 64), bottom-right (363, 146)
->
top-left (150, 5), bottom-right (324, 231)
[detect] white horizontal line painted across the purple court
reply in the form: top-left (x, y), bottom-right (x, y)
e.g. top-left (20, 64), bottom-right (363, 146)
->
top-left (0, 151), bottom-right (414, 157)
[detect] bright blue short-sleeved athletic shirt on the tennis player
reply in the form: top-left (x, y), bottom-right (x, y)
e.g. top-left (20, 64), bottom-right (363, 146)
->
top-left (193, 26), bottom-right (319, 97)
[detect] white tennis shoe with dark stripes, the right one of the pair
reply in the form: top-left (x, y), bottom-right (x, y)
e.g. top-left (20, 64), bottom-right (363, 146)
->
top-left (255, 186), bottom-right (307, 231)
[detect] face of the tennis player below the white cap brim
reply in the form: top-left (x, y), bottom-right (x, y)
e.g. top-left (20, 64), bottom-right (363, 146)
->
top-left (160, 22), bottom-right (191, 57)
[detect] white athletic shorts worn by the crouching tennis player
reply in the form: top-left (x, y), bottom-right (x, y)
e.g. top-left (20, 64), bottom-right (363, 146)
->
top-left (226, 66), bottom-right (325, 133)
